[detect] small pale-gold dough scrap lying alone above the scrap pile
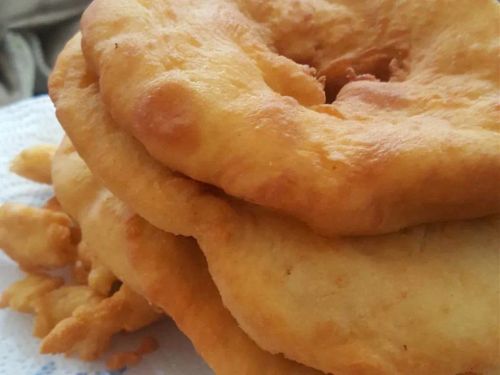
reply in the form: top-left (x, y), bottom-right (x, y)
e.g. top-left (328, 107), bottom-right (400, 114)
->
top-left (10, 145), bottom-right (56, 184)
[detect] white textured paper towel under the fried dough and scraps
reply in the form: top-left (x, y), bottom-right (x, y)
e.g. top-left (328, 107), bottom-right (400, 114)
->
top-left (0, 96), bottom-right (212, 375)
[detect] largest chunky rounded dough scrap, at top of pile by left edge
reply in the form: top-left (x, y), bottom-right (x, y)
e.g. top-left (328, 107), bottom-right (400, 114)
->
top-left (0, 203), bottom-right (75, 269)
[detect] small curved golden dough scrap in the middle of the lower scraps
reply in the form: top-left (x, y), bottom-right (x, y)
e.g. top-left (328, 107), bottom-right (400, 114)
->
top-left (33, 285), bottom-right (103, 338)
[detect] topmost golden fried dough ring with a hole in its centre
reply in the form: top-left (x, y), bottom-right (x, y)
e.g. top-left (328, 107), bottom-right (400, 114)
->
top-left (82, 0), bottom-right (500, 235)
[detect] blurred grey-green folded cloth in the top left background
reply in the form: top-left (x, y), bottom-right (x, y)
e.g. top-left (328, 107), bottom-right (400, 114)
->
top-left (0, 0), bottom-right (90, 107)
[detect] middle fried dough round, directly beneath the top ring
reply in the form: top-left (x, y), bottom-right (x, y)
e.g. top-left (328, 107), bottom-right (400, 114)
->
top-left (50, 38), bottom-right (500, 375)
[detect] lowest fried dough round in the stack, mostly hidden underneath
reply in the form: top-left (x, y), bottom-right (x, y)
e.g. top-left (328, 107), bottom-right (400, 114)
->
top-left (53, 139), bottom-right (320, 375)
